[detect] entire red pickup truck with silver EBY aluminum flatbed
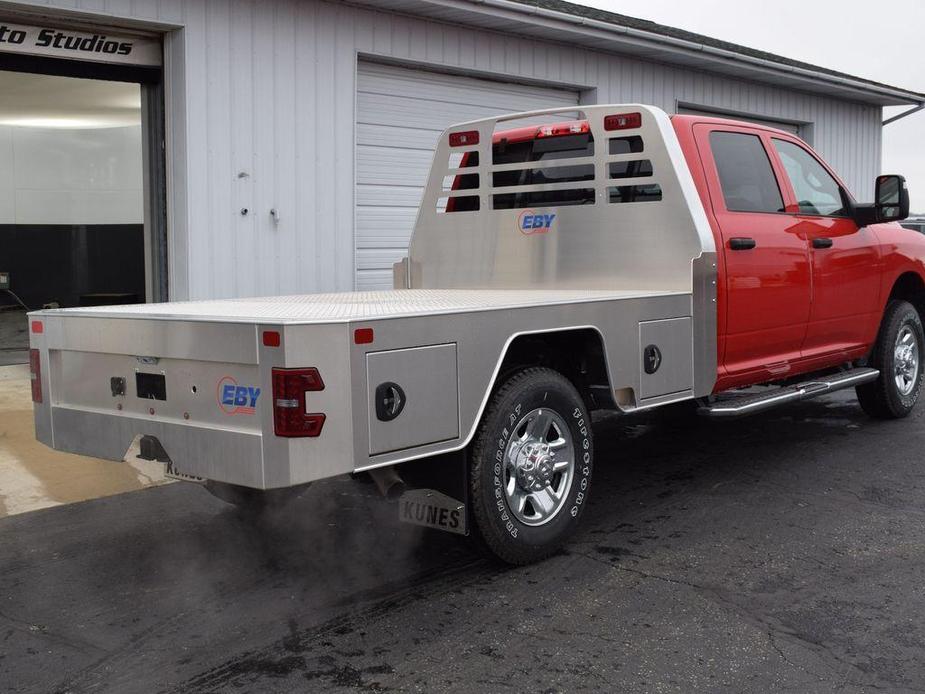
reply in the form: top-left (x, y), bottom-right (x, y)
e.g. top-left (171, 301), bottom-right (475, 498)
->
top-left (31, 104), bottom-right (925, 563)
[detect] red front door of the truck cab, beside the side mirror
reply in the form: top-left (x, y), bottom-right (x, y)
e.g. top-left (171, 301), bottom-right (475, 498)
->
top-left (771, 136), bottom-right (880, 358)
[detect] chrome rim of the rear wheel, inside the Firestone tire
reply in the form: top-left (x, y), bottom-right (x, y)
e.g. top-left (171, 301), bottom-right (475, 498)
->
top-left (504, 407), bottom-right (575, 526)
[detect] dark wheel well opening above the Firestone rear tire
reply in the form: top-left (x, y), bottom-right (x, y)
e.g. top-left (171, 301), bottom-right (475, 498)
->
top-left (494, 328), bottom-right (617, 410)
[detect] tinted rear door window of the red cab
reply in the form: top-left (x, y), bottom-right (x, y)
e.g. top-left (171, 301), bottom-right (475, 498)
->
top-left (710, 130), bottom-right (784, 212)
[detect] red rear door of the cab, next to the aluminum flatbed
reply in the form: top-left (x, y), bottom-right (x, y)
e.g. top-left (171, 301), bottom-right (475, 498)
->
top-left (694, 123), bottom-right (811, 378)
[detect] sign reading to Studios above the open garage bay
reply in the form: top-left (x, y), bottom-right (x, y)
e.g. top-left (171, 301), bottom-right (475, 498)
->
top-left (0, 24), bottom-right (161, 65)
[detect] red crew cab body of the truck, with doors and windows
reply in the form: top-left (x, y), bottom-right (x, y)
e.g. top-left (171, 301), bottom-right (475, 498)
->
top-left (672, 115), bottom-right (925, 392)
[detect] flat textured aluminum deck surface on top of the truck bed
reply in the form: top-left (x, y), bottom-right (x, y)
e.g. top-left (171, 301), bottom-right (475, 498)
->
top-left (37, 289), bottom-right (684, 324)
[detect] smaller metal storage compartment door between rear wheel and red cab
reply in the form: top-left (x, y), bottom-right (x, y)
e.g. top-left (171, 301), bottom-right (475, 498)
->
top-left (639, 318), bottom-right (694, 400)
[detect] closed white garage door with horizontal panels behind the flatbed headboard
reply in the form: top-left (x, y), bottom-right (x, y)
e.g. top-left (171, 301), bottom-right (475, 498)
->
top-left (356, 62), bottom-right (578, 289)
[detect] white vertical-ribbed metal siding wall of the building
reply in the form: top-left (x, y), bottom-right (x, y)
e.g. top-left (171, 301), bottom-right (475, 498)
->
top-left (0, 0), bottom-right (881, 298)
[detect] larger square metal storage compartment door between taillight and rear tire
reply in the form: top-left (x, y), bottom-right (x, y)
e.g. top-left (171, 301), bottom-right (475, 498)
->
top-left (366, 344), bottom-right (459, 455)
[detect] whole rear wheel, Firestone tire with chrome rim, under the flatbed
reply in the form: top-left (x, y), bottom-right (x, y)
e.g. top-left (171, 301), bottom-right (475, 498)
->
top-left (469, 368), bottom-right (594, 564)
